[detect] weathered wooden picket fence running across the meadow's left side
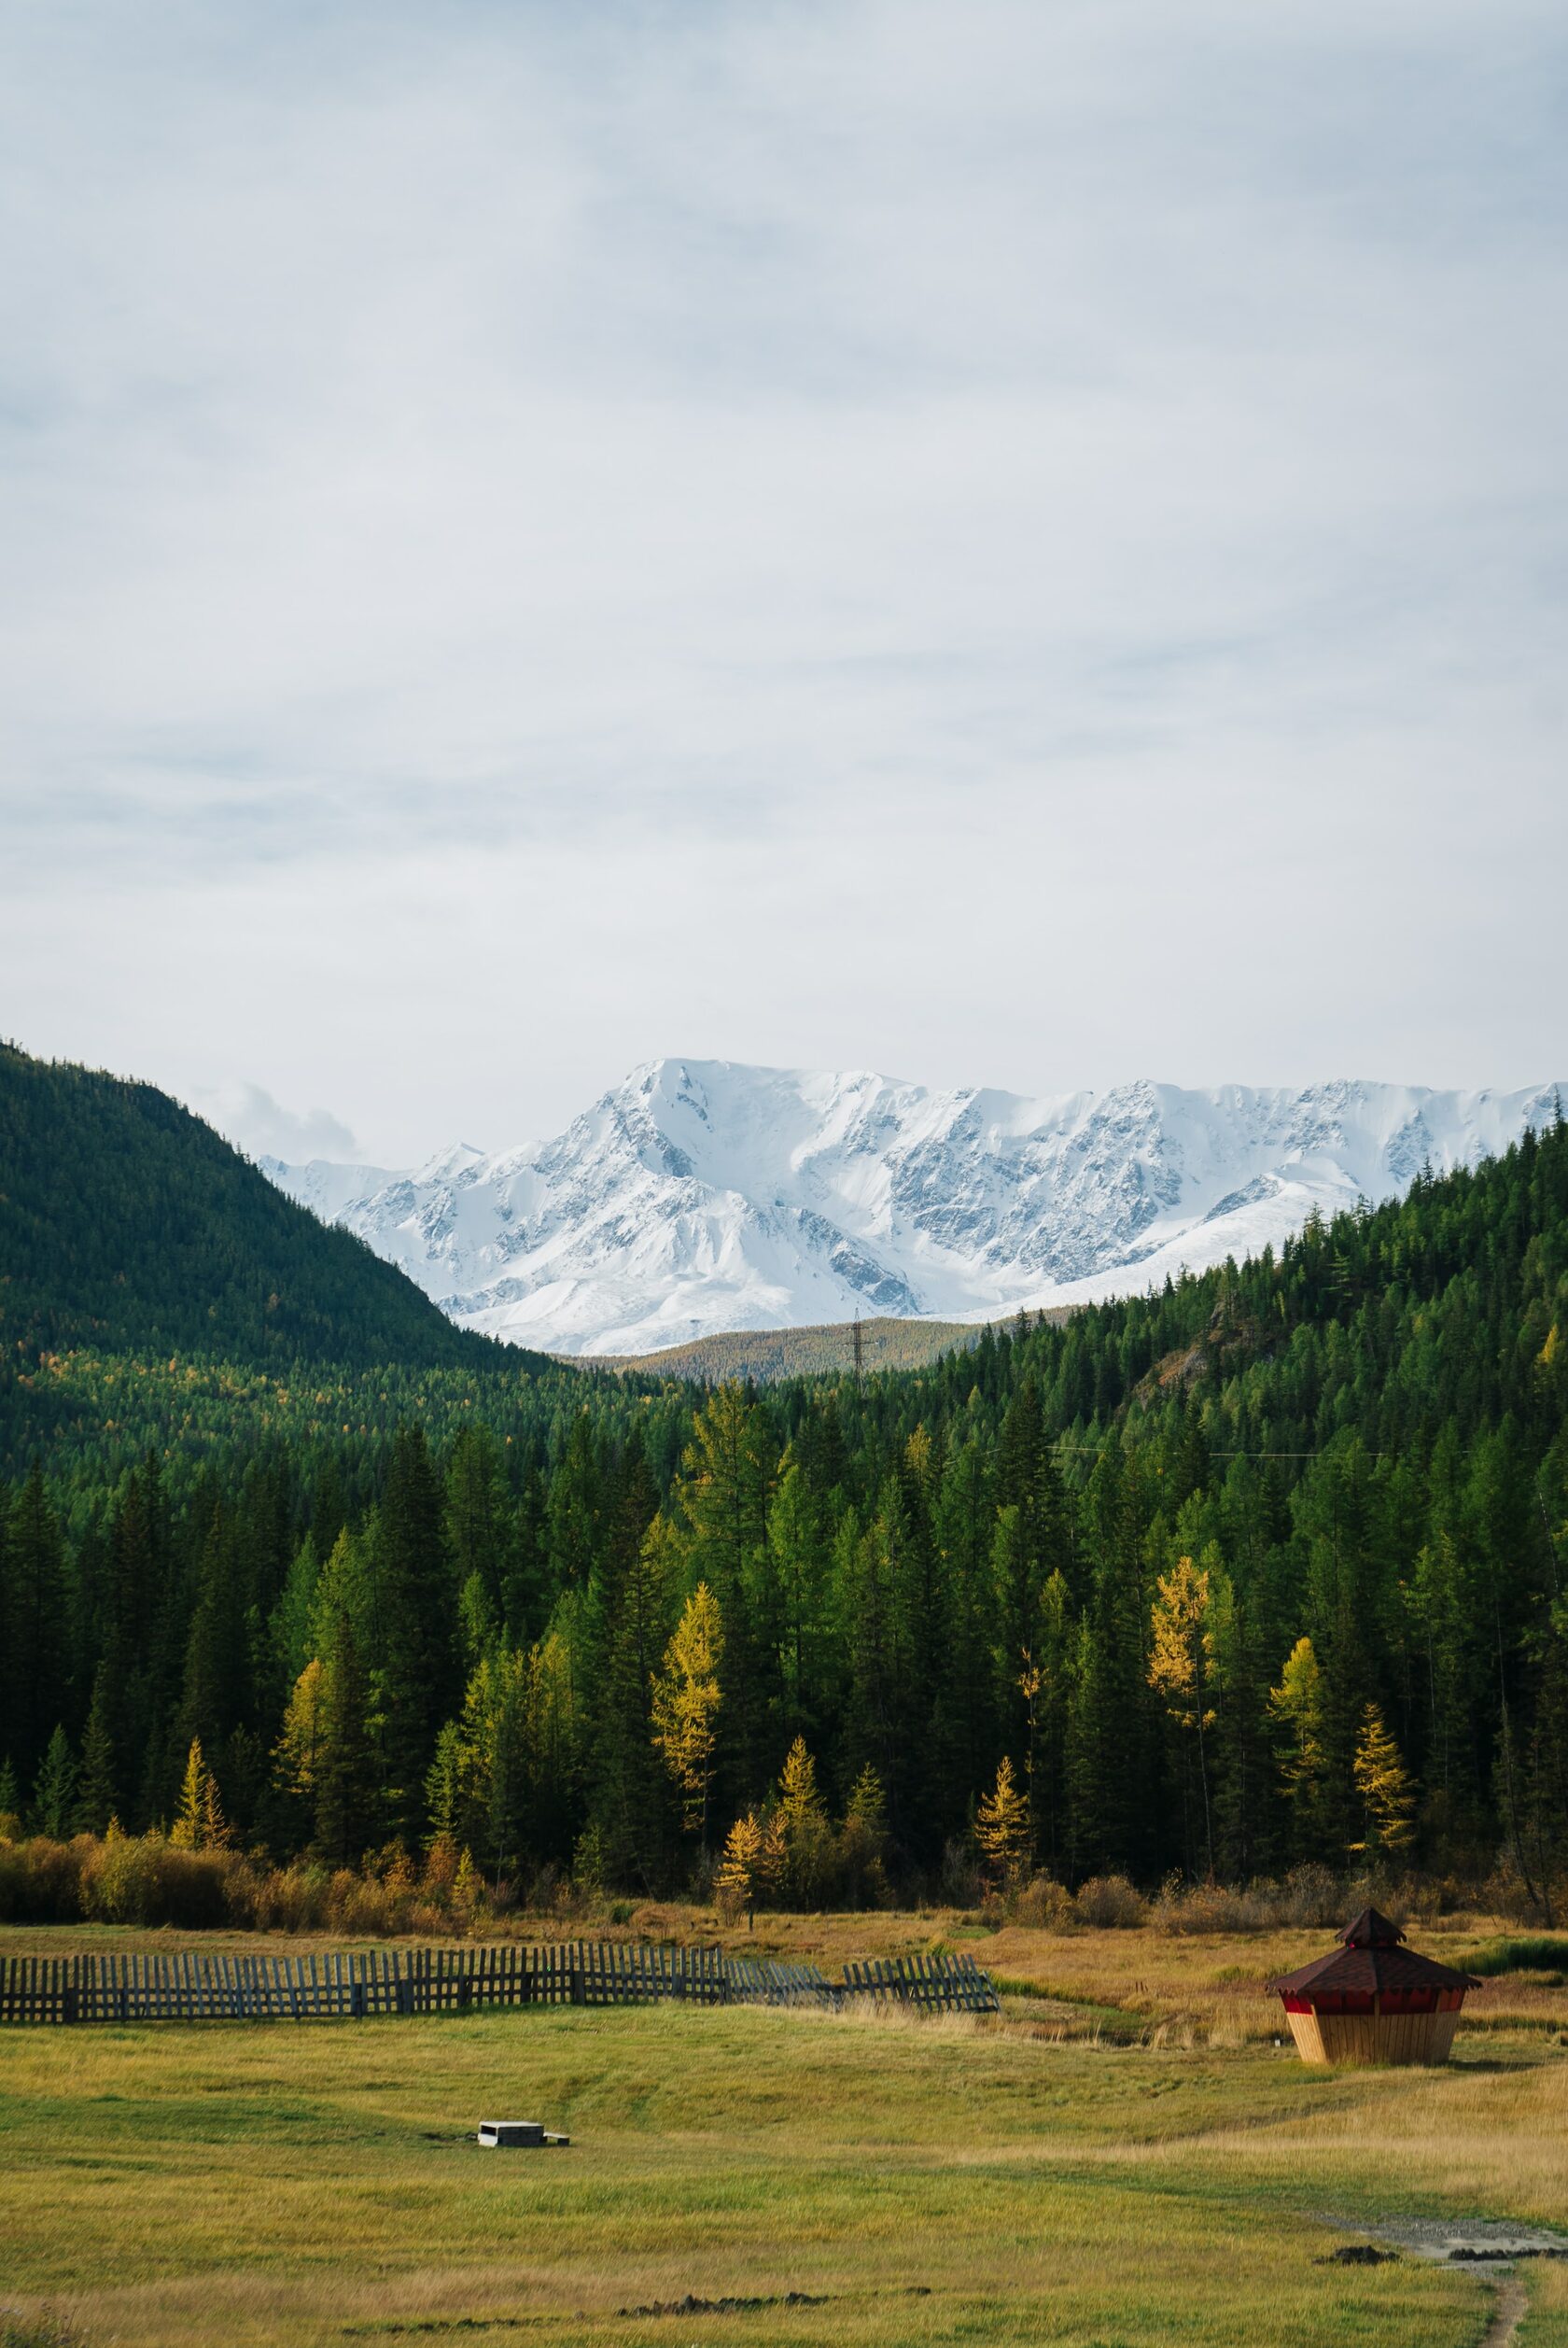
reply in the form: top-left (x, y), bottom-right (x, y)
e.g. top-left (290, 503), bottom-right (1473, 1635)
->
top-left (0, 1939), bottom-right (998, 2021)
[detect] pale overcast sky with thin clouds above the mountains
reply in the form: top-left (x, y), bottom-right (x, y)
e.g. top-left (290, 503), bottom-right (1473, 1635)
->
top-left (0, 0), bottom-right (1568, 1162)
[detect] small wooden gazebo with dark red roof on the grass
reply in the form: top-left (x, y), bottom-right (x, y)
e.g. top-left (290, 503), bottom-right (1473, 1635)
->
top-left (1270, 1909), bottom-right (1481, 2064)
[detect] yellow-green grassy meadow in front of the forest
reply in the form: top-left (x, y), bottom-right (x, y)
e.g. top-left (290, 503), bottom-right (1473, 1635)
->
top-left (0, 1919), bottom-right (1568, 2348)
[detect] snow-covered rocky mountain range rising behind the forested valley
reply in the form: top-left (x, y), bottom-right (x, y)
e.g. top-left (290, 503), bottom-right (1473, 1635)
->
top-left (260, 1059), bottom-right (1556, 1353)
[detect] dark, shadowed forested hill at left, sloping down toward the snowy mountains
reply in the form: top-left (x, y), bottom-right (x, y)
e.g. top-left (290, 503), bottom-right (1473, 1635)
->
top-left (0, 1045), bottom-right (542, 1371)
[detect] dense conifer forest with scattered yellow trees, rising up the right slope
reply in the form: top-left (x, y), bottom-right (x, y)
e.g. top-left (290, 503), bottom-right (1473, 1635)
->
top-left (0, 1099), bottom-right (1568, 1897)
